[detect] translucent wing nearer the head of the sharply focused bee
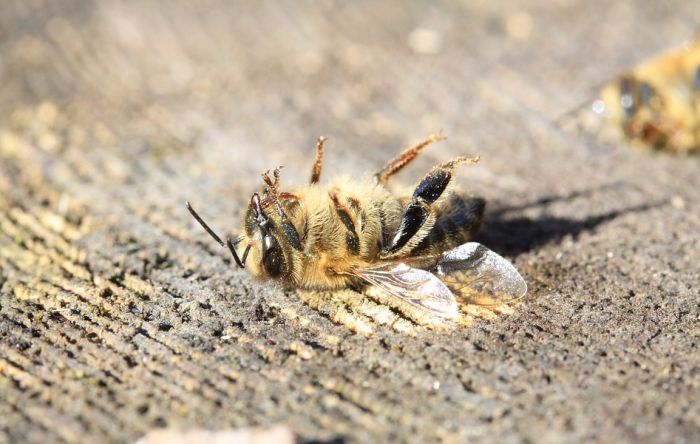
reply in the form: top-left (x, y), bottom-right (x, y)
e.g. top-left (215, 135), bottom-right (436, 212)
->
top-left (353, 262), bottom-right (458, 318)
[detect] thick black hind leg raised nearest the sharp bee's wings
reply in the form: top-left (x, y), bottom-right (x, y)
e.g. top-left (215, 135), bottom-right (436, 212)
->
top-left (379, 157), bottom-right (479, 259)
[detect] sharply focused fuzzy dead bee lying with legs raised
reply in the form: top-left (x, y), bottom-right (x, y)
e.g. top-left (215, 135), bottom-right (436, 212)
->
top-left (187, 134), bottom-right (527, 318)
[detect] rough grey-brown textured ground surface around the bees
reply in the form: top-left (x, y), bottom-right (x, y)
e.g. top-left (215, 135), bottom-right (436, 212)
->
top-left (0, 0), bottom-right (700, 442)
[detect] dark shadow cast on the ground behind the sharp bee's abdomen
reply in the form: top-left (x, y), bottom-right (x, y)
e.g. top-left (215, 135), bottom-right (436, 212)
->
top-left (475, 184), bottom-right (666, 256)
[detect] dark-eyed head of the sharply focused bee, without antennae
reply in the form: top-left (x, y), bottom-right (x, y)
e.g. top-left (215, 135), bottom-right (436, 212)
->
top-left (244, 193), bottom-right (288, 279)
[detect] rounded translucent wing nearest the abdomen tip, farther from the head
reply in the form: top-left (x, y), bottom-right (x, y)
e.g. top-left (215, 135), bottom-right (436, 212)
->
top-left (435, 242), bottom-right (527, 306)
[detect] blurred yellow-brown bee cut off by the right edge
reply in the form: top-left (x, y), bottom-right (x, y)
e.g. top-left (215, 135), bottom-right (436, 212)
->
top-left (593, 39), bottom-right (700, 153)
